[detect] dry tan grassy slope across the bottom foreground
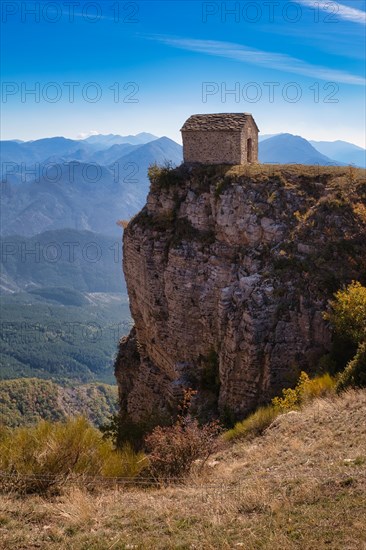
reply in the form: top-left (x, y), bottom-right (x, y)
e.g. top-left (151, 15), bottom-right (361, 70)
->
top-left (0, 390), bottom-right (366, 550)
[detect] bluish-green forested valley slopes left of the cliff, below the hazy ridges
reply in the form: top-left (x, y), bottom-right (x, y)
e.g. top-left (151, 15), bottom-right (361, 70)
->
top-left (0, 288), bottom-right (130, 384)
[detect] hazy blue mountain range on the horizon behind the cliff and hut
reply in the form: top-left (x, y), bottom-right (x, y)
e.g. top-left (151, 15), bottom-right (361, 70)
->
top-left (0, 133), bottom-right (366, 237)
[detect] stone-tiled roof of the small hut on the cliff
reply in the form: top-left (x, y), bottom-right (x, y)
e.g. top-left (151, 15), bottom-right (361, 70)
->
top-left (182, 113), bottom-right (255, 131)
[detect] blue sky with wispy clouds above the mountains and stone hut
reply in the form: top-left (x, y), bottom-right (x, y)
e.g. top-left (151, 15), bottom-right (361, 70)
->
top-left (1, 0), bottom-right (366, 146)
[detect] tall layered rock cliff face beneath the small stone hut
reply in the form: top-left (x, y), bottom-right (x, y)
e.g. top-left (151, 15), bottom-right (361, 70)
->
top-left (116, 166), bottom-right (366, 420)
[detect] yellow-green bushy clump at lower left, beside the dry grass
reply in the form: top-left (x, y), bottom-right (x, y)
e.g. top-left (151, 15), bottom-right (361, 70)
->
top-left (0, 417), bottom-right (147, 494)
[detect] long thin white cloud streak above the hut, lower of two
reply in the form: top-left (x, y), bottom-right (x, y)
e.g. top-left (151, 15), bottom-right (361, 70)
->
top-left (149, 35), bottom-right (366, 86)
